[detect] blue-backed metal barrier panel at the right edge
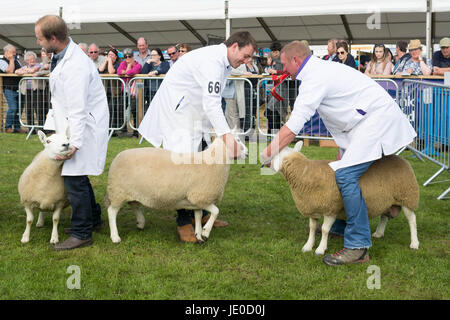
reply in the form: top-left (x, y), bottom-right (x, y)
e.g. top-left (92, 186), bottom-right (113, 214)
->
top-left (400, 80), bottom-right (450, 200)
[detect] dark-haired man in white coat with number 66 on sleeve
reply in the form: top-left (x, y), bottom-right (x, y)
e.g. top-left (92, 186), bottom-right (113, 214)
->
top-left (139, 31), bottom-right (256, 242)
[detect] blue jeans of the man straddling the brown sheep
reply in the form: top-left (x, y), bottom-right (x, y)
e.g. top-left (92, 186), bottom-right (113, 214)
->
top-left (330, 161), bottom-right (373, 249)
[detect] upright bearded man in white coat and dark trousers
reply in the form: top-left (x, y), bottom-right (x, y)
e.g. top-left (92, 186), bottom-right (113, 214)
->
top-left (35, 15), bottom-right (109, 250)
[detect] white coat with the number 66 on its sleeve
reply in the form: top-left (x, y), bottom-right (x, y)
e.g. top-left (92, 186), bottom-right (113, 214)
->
top-left (139, 44), bottom-right (231, 153)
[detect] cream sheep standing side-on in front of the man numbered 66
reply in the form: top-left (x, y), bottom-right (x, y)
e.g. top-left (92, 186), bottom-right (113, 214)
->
top-left (105, 131), bottom-right (248, 243)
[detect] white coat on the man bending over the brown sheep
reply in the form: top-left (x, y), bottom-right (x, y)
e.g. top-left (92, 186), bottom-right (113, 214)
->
top-left (286, 56), bottom-right (416, 171)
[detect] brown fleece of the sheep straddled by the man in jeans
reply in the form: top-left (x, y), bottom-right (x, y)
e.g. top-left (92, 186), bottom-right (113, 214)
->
top-left (281, 153), bottom-right (419, 219)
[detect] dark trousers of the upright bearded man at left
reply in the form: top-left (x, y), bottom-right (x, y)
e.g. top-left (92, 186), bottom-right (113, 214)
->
top-left (64, 176), bottom-right (101, 240)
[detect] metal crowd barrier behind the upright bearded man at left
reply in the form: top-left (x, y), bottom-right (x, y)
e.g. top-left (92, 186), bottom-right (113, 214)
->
top-left (19, 77), bottom-right (128, 140)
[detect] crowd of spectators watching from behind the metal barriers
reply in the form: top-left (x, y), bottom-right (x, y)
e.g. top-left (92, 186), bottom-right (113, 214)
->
top-left (0, 37), bottom-right (450, 133)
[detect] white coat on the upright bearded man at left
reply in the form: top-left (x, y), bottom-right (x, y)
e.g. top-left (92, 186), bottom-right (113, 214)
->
top-left (50, 39), bottom-right (109, 176)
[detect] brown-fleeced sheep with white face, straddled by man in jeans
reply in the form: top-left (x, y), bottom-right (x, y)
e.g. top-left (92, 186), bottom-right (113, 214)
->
top-left (270, 141), bottom-right (419, 255)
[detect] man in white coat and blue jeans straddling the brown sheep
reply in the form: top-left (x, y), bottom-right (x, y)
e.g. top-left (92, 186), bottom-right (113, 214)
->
top-left (261, 41), bottom-right (416, 266)
